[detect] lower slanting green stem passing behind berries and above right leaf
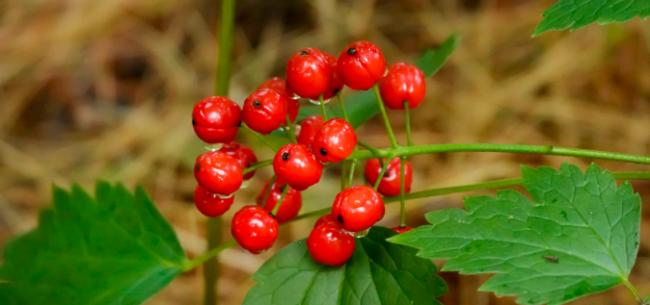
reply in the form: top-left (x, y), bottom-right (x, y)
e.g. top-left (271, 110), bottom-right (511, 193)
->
top-left (289, 172), bottom-right (650, 222)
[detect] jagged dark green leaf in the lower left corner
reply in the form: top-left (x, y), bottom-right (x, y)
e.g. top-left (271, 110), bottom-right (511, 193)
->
top-left (0, 183), bottom-right (186, 305)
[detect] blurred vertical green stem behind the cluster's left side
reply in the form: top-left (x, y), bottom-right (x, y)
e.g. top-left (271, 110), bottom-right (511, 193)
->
top-left (203, 0), bottom-right (235, 305)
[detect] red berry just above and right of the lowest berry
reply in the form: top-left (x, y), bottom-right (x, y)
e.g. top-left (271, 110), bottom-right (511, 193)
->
top-left (332, 186), bottom-right (384, 232)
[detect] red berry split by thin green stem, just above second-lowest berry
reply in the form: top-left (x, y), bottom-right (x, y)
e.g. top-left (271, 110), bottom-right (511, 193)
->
top-left (257, 180), bottom-right (302, 223)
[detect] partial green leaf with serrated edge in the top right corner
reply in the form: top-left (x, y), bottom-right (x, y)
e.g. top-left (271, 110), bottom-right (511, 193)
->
top-left (533, 0), bottom-right (650, 36)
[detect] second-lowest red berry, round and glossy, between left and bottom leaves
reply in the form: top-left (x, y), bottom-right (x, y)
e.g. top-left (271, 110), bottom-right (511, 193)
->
top-left (230, 205), bottom-right (279, 253)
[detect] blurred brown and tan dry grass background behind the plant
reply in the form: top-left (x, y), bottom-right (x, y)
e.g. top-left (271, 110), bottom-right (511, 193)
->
top-left (0, 0), bottom-right (650, 305)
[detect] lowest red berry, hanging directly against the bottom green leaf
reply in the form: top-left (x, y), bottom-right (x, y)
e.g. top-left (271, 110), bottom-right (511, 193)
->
top-left (307, 215), bottom-right (355, 267)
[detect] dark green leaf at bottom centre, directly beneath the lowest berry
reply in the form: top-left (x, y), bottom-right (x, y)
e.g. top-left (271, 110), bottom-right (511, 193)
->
top-left (244, 227), bottom-right (447, 305)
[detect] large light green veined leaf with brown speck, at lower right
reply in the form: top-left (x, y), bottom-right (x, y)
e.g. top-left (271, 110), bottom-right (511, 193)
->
top-left (389, 164), bottom-right (641, 305)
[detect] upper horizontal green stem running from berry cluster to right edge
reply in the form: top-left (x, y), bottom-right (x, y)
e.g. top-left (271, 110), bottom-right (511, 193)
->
top-left (348, 143), bottom-right (650, 164)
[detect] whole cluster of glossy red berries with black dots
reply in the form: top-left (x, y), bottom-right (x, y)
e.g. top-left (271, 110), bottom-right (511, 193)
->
top-left (192, 41), bottom-right (425, 266)
